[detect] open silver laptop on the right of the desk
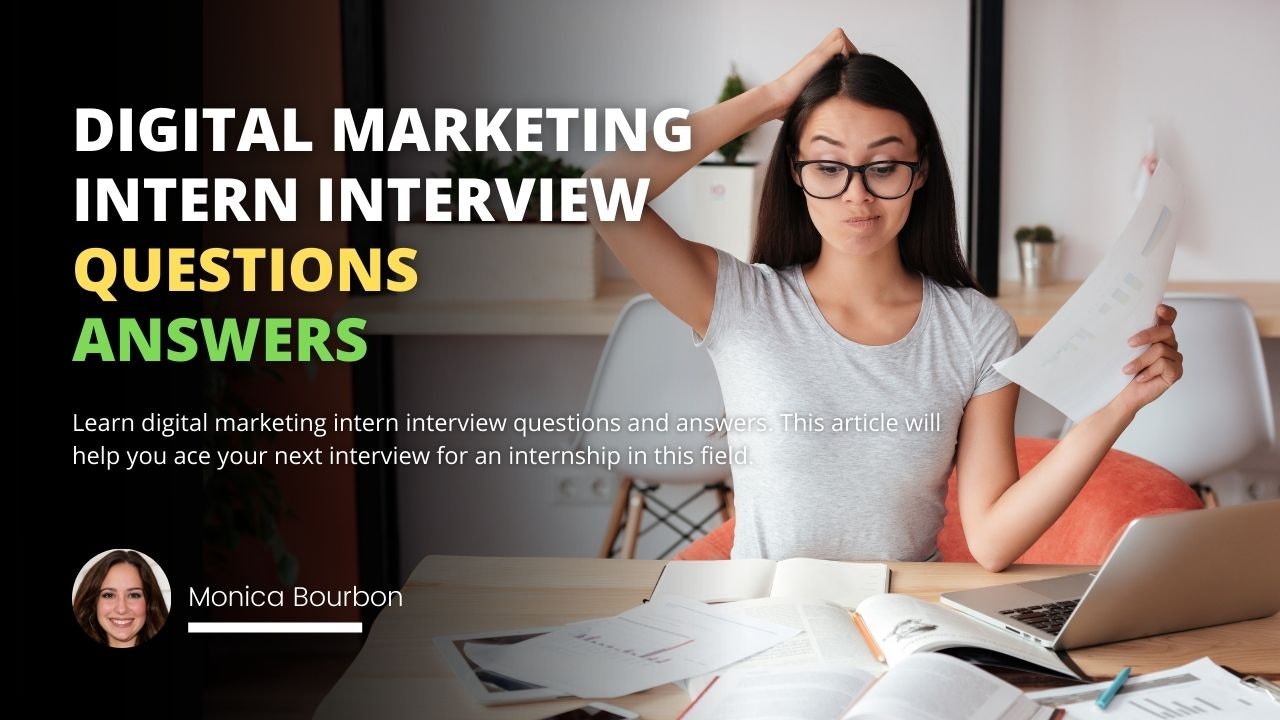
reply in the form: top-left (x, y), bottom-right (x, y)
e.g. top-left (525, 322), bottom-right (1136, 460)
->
top-left (941, 500), bottom-right (1280, 651)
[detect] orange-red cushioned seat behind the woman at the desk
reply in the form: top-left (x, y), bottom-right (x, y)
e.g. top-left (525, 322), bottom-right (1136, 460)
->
top-left (676, 437), bottom-right (1202, 565)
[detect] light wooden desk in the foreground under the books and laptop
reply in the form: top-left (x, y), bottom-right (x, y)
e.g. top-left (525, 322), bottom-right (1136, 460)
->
top-left (316, 556), bottom-right (1280, 720)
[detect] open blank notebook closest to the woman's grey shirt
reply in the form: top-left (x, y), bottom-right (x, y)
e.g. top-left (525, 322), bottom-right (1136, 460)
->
top-left (652, 557), bottom-right (888, 610)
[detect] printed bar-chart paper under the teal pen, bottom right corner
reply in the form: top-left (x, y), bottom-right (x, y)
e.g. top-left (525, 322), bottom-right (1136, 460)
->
top-left (1028, 657), bottom-right (1280, 720)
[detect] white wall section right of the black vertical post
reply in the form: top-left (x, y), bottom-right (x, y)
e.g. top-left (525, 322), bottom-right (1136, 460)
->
top-left (1000, 0), bottom-right (1280, 281)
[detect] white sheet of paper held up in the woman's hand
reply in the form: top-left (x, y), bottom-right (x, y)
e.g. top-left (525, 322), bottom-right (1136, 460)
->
top-left (996, 160), bottom-right (1181, 423)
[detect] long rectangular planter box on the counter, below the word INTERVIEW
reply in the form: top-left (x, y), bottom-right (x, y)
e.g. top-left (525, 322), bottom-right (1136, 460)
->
top-left (396, 223), bottom-right (603, 297)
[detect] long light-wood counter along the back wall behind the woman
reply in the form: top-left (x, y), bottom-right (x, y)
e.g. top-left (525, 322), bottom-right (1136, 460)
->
top-left (342, 281), bottom-right (1280, 338)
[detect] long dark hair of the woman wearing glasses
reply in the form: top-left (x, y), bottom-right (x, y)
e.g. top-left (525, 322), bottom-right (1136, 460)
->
top-left (751, 55), bottom-right (978, 288)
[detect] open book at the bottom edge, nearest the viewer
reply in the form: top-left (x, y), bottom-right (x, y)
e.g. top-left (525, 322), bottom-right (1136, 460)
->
top-left (680, 655), bottom-right (1065, 720)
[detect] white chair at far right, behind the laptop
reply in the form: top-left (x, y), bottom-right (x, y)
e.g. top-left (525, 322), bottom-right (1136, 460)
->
top-left (1064, 293), bottom-right (1275, 505)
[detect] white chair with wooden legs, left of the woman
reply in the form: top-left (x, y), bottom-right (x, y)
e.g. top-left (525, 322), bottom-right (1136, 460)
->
top-left (573, 295), bottom-right (732, 559)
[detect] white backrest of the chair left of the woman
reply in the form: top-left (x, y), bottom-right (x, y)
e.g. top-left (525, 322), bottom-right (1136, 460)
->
top-left (575, 295), bottom-right (728, 483)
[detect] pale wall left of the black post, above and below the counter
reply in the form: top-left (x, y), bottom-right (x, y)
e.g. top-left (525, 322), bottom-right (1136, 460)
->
top-left (385, 0), bottom-right (969, 574)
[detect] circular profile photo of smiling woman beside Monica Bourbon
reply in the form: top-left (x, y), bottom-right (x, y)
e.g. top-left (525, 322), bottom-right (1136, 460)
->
top-left (72, 548), bottom-right (172, 647)
